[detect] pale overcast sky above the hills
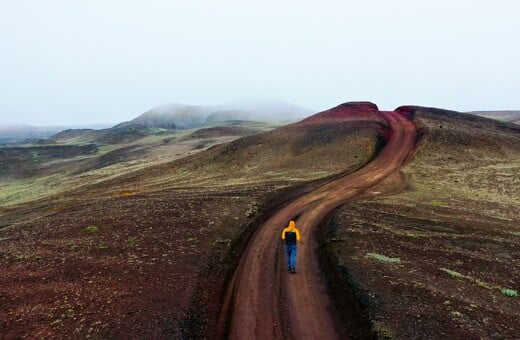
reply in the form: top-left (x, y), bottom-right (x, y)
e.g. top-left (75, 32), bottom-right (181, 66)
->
top-left (0, 0), bottom-right (520, 125)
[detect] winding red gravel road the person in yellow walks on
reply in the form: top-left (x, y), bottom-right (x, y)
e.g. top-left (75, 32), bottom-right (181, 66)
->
top-left (218, 111), bottom-right (417, 339)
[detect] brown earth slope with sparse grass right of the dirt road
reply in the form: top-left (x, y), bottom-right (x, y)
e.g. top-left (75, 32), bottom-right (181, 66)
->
top-left (320, 107), bottom-right (520, 339)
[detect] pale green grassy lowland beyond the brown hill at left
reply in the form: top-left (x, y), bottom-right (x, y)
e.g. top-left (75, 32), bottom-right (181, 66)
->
top-left (0, 123), bottom-right (279, 207)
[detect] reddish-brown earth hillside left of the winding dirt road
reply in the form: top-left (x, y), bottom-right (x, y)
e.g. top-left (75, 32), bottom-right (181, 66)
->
top-left (0, 108), bottom-right (379, 338)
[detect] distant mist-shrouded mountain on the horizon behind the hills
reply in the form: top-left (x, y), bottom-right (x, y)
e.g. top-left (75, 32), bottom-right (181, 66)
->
top-left (116, 100), bottom-right (314, 129)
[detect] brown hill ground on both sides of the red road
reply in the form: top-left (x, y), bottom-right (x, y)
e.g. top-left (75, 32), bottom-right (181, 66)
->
top-left (0, 103), bottom-right (520, 338)
